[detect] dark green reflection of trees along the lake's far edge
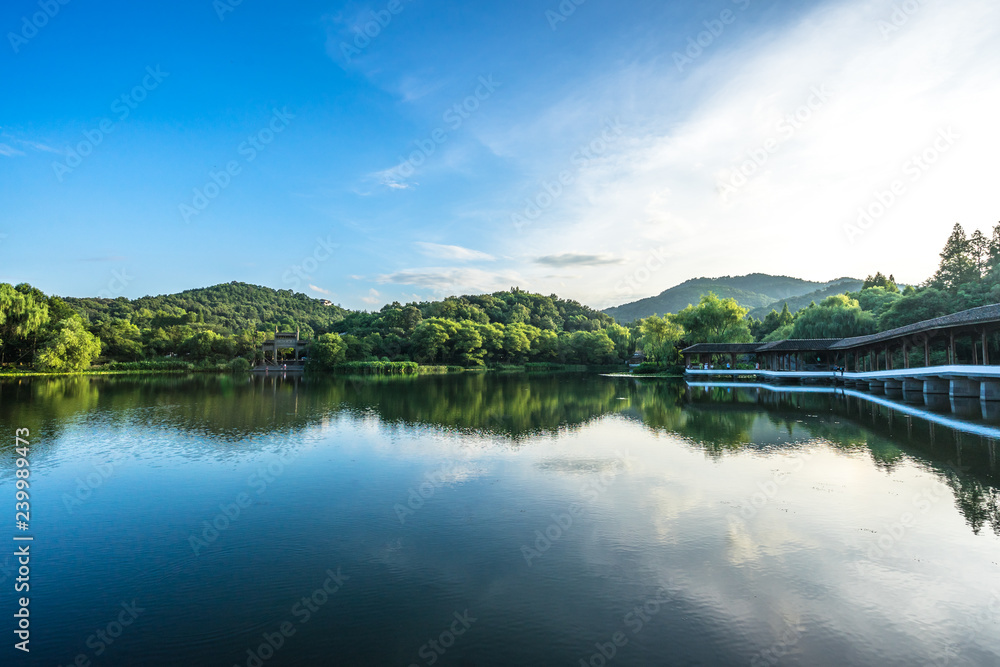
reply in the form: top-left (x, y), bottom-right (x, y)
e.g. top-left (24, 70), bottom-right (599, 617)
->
top-left (0, 373), bottom-right (1000, 531)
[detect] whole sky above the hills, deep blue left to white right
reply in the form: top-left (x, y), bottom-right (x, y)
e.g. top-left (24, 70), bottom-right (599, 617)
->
top-left (0, 0), bottom-right (1000, 309)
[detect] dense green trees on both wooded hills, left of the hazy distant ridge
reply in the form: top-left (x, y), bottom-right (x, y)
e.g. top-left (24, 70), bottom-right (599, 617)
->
top-left (0, 283), bottom-right (635, 374)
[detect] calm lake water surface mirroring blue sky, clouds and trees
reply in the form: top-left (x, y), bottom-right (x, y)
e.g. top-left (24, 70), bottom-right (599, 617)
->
top-left (0, 374), bottom-right (1000, 667)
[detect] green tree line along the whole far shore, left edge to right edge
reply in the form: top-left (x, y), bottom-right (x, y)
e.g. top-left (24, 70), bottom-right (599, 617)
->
top-left (7, 224), bottom-right (1000, 372)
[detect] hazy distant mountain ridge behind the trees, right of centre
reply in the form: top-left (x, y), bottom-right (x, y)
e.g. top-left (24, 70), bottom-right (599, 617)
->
top-left (603, 273), bottom-right (864, 322)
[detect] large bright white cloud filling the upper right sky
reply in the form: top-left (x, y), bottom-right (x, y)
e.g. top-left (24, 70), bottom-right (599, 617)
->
top-left (483, 0), bottom-right (1000, 306)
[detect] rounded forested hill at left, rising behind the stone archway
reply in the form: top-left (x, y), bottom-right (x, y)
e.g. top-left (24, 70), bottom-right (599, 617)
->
top-left (63, 282), bottom-right (347, 334)
